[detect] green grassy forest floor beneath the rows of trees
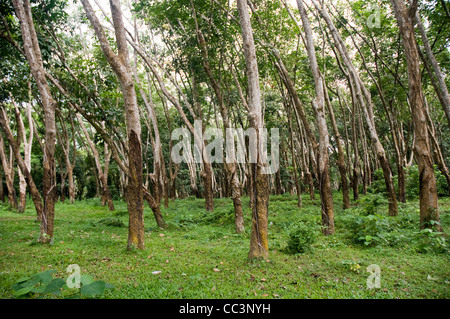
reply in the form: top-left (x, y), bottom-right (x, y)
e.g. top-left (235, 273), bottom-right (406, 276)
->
top-left (0, 193), bottom-right (450, 299)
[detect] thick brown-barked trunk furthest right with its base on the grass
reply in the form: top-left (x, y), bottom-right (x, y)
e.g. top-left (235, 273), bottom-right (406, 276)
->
top-left (391, 0), bottom-right (442, 231)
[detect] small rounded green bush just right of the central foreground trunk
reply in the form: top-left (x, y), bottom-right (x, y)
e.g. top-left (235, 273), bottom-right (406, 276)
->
top-left (286, 223), bottom-right (318, 254)
